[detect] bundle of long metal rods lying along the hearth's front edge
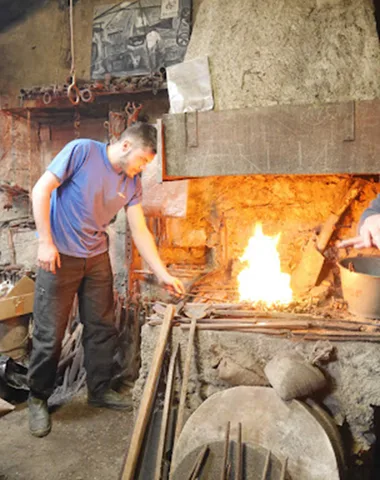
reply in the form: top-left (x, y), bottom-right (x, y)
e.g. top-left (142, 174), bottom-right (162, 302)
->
top-left (147, 302), bottom-right (380, 342)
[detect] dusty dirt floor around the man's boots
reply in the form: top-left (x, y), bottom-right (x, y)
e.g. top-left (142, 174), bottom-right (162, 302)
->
top-left (0, 390), bottom-right (134, 480)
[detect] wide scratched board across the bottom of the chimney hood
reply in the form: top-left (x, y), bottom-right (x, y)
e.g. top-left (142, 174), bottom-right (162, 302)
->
top-left (163, 100), bottom-right (380, 180)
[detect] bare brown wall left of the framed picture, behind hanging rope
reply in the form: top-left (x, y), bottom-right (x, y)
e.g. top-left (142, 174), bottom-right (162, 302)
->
top-left (0, 0), bottom-right (115, 106)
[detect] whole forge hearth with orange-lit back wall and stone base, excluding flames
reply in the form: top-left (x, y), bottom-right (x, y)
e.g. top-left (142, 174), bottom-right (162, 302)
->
top-left (132, 163), bottom-right (380, 470)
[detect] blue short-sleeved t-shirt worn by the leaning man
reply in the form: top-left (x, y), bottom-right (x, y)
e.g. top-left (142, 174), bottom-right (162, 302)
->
top-left (47, 139), bottom-right (142, 258)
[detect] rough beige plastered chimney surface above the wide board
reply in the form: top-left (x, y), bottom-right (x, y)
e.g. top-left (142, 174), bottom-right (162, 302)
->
top-left (186, 0), bottom-right (380, 110)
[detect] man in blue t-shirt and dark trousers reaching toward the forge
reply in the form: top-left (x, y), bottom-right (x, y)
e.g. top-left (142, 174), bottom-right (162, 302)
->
top-left (28, 123), bottom-right (184, 437)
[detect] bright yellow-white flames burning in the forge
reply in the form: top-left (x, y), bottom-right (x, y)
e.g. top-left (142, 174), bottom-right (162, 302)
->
top-left (238, 223), bottom-right (293, 305)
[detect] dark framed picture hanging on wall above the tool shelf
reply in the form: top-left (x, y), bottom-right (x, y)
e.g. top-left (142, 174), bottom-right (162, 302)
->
top-left (91, 0), bottom-right (191, 79)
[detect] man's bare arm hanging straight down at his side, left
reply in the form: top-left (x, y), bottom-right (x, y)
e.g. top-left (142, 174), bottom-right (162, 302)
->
top-left (32, 171), bottom-right (61, 273)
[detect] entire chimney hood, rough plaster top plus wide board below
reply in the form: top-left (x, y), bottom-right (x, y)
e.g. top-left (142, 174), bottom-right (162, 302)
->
top-left (162, 0), bottom-right (380, 179)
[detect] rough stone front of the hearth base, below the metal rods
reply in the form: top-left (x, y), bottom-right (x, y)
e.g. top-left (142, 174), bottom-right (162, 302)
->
top-left (134, 325), bottom-right (380, 456)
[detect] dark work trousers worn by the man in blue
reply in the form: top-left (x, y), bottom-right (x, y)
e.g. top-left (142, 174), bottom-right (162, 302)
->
top-left (28, 252), bottom-right (117, 399)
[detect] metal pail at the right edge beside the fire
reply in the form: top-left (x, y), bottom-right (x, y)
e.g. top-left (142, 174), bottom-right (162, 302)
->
top-left (338, 256), bottom-right (380, 318)
